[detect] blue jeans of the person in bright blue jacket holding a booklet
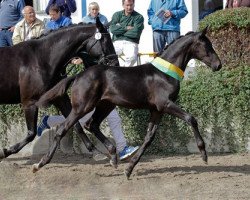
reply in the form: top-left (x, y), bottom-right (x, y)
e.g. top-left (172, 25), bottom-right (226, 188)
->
top-left (153, 30), bottom-right (180, 52)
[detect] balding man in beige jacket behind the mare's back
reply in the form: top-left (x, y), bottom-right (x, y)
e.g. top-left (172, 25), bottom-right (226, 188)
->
top-left (12, 6), bottom-right (44, 44)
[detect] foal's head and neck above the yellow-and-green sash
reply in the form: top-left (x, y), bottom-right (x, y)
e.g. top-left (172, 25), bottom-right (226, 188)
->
top-left (161, 28), bottom-right (221, 71)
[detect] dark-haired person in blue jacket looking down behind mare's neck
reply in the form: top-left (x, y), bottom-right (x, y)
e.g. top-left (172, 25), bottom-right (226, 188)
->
top-left (45, 5), bottom-right (72, 30)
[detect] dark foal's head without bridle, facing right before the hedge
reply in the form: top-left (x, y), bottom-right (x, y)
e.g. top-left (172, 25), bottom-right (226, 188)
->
top-left (192, 28), bottom-right (221, 71)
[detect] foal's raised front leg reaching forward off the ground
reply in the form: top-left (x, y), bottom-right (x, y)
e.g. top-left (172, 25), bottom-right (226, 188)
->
top-left (164, 102), bottom-right (207, 163)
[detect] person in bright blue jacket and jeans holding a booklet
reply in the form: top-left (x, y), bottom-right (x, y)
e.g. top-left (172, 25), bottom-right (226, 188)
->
top-left (148, 0), bottom-right (188, 52)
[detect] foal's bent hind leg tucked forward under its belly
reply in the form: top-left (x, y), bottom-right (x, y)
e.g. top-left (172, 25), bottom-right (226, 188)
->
top-left (84, 101), bottom-right (117, 167)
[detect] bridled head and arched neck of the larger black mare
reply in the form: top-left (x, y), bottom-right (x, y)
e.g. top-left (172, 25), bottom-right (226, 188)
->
top-left (37, 17), bottom-right (119, 71)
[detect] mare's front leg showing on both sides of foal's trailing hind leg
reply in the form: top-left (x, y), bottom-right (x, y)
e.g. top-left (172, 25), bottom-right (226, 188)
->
top-left (53, 95), bottom-right (96, 152)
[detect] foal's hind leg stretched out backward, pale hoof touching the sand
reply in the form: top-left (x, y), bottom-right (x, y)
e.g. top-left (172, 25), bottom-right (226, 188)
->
top-left (33, 111), bottom-right (80, 173)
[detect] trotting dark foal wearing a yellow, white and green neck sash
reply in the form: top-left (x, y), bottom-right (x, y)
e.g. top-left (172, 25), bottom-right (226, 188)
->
top-left (33, 29), bottom-right (221, 178)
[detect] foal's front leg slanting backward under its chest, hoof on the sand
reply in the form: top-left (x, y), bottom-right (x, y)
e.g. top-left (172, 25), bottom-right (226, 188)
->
top-left (124, 111), bottom-right (162, 179)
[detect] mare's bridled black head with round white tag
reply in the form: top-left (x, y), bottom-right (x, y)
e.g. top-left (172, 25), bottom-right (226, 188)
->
top-left (86, 17), bottom-right (119, 66)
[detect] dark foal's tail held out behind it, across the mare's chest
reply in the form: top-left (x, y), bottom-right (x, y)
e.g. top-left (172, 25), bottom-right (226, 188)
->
top-left (36, 74), bottom-right (77, 107)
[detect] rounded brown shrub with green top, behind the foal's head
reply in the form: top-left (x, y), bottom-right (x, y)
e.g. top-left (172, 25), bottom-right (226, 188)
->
top-left (200, 7), bottom-right (250, 68)
